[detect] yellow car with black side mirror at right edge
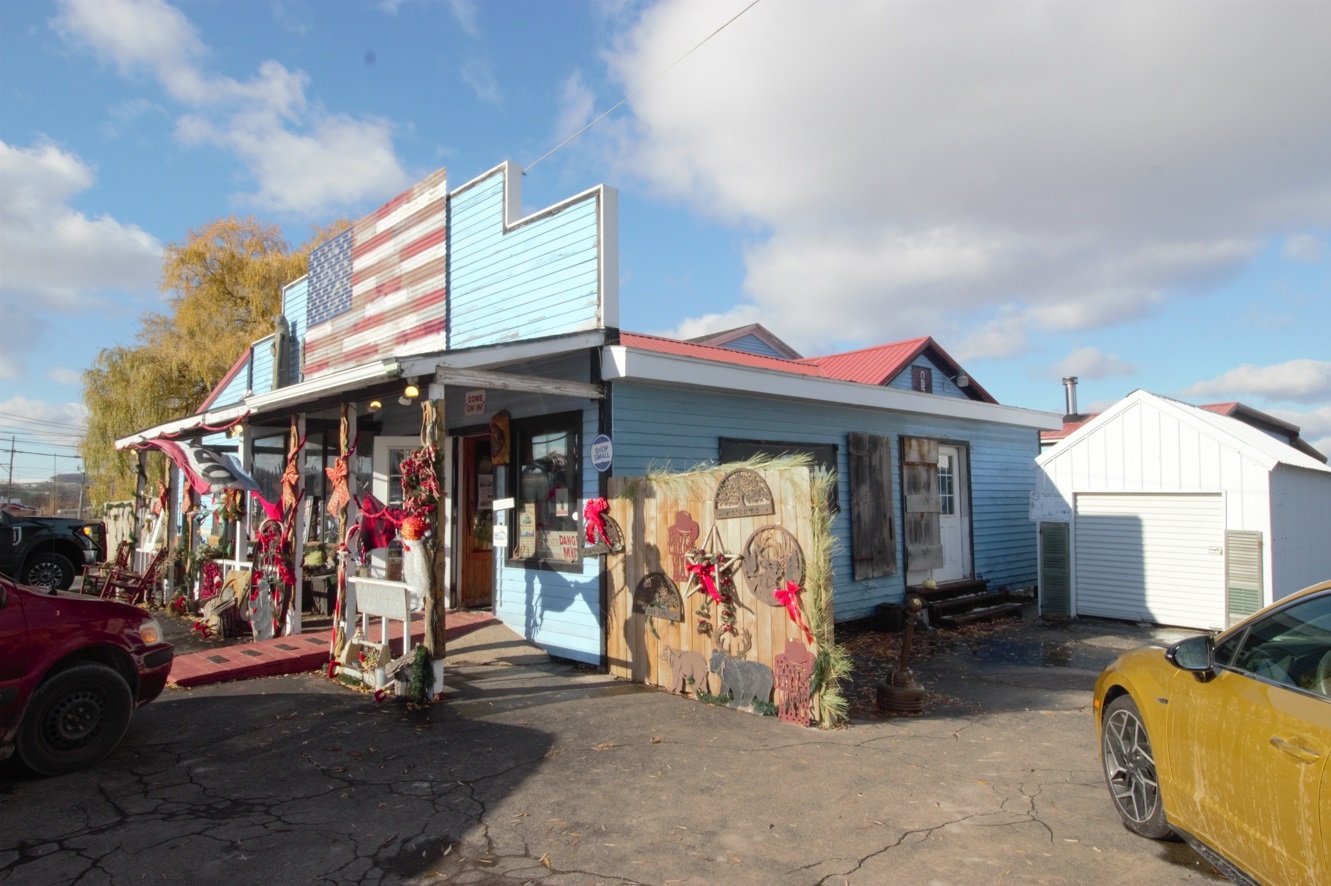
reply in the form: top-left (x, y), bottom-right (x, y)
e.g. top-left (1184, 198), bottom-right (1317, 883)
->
top-left (1095, 581), bottom-right (1331, 886)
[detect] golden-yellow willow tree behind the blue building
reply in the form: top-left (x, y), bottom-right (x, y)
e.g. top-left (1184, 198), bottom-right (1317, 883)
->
top-left (83, 217), bottom-right (347, 502)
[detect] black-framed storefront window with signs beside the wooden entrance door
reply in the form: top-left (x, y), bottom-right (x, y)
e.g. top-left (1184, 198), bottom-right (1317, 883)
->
top-left (508, 412), bottom-right (582, 569)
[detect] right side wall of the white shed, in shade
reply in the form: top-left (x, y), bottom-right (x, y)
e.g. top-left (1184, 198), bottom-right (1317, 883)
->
top-left (1266, 464), bottom-right (1331, 600)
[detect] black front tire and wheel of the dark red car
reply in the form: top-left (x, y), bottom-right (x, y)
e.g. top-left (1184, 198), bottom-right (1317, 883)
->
top-left (15, 664), bottom-right (134, 776)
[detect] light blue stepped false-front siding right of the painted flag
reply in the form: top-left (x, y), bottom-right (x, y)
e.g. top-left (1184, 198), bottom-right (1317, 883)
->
top-left (449, 172), bottom-right (600, 350)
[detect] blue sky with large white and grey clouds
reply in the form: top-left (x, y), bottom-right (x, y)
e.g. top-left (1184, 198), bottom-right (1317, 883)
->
top-left (0, 0), bottom-right (1331, 489)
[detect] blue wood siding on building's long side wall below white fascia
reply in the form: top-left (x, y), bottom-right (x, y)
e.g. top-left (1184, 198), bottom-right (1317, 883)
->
top-left (612, 382), bottom-right (1040, 621)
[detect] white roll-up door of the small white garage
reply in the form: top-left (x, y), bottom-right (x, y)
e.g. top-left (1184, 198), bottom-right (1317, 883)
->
top-left (1073, 494), bottom-right (1225, 629)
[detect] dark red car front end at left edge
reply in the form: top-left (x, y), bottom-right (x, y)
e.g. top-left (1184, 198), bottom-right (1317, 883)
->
top-left (0, 573), bottom-right (174, 776)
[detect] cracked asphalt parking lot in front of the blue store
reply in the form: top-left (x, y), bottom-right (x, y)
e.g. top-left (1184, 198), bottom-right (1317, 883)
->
top-left (0, 614), bottom-right (1221, 886)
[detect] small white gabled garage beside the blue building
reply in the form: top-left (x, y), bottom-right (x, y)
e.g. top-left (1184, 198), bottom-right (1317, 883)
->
top-left (1032, 391), bottom-right (1331, 629)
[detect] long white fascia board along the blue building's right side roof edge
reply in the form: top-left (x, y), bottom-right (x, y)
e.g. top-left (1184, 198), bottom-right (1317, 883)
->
top-left (602, 345), bottom-right (1062, 431)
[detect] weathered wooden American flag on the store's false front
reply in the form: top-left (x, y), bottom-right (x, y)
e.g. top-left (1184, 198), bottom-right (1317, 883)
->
top-left (303, 169), bottom-right (449, 378)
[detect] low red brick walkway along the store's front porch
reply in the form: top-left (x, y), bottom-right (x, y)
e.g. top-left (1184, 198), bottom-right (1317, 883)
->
top-left (169, 612), bottom-right (498, 688)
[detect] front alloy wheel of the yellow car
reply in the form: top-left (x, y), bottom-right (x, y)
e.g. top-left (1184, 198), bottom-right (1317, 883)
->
top-left (1101, 696), bottom-right (1174, 839)
